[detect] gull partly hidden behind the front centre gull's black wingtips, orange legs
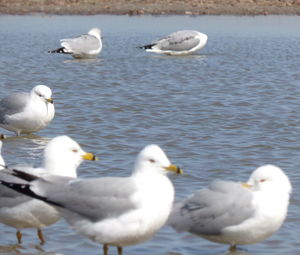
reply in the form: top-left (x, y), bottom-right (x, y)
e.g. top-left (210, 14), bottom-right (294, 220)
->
top-left (0, 136), bottom-right (96, 244)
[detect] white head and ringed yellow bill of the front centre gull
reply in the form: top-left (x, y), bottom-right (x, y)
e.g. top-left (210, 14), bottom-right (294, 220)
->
top-left (134, 144), bottom-right (183, 175)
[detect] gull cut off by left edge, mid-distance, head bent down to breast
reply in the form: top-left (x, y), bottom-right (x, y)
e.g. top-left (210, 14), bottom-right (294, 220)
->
top-left (0, 85), bottom-right (55, 136)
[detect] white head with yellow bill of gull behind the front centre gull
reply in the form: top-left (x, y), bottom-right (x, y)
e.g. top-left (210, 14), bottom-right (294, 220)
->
top-left (44, 136), bottom-right (97, 177)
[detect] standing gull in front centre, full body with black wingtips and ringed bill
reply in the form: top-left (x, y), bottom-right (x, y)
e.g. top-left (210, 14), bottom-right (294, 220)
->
top-left (0, 145), bottom-right (182, 255)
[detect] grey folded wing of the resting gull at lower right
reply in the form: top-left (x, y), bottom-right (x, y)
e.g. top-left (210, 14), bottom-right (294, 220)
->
top-left (169, 181), bottom-right (254, 235)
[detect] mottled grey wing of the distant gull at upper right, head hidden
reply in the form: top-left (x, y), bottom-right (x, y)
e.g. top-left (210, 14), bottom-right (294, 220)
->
top-left (155, 30), bottom-right (200, 51)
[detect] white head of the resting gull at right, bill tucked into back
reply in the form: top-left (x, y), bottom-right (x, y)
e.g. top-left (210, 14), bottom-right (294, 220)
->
top-left (247, 165), bottom-right (292, 194)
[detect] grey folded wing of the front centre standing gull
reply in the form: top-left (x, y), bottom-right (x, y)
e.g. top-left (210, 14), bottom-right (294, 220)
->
top-left (34, 177), bottom-right (136, 221)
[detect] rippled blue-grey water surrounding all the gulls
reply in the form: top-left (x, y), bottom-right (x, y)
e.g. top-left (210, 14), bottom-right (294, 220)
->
top-left (0, 16), bottom-right (300, 255)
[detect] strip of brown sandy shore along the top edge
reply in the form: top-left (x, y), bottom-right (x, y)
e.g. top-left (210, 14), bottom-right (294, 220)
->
top-left (0, 0), bottom-right (300, 15)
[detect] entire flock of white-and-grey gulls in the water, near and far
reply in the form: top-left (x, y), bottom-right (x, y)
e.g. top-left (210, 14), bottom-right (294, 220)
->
top-left (0, 28), bottom-right (292, 255)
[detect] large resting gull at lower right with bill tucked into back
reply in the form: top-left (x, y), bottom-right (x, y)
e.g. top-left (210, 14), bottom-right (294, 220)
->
top-left (168, 165), bottom-right (292, 250)
